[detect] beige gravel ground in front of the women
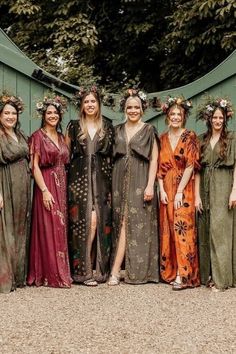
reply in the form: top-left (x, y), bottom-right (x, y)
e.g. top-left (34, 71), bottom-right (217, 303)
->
top-left (0, 283), bottom-right (236, 354)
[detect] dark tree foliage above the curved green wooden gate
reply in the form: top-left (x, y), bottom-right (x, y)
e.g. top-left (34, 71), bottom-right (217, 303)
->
top-left (0, 0), bottom-right (236, 92)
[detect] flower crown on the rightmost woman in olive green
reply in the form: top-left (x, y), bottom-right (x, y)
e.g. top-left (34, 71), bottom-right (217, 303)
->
top-left (196, 96), bottom-right (234, 121)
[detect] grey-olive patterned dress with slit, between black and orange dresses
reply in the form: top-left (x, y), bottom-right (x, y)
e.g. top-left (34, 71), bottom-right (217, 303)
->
top-left (112, 123), bottom-right (159, 284)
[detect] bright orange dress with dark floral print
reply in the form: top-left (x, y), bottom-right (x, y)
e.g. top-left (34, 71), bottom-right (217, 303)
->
top-left (158, 129), bottom-right (200, 287)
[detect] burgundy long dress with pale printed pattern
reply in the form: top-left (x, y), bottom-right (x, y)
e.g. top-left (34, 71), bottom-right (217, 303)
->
top-left (27, 129), bottom-right (72, 287)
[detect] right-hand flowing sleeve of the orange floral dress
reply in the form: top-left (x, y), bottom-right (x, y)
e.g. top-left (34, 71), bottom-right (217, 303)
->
top-left (186, 132), bottom-right (201, 172)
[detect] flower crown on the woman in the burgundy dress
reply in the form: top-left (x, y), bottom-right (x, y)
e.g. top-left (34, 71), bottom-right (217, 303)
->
top-left (36, 92), bottom-right (67, 116)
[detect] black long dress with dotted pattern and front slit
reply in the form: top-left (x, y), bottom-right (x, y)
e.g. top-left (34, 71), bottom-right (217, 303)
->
top-left (67, 119), bottom-right (114, 282)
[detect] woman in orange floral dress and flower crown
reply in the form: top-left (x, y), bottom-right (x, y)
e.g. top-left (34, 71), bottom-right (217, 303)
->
top-left (158, 97), bottom-right (200, 290)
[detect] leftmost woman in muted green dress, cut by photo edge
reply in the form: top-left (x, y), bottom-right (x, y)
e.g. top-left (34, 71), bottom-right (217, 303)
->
top-left (0, 93), bottom-right (30, 293)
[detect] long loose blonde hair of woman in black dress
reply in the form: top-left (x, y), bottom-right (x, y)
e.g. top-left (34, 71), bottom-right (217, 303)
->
top-left (79, 92), bottom-right (104, 140)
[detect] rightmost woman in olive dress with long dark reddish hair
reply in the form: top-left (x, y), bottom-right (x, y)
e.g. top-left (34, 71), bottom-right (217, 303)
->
top-left (196, 97), bottom-right (236, 291)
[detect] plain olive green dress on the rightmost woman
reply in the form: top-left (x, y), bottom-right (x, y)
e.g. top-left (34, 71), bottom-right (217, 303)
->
top-left (198, 132), bottom-right (236, 289)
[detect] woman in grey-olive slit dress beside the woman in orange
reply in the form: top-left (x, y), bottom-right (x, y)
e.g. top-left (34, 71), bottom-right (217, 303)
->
top-left (108, 89), bottom-right (159, 285)
